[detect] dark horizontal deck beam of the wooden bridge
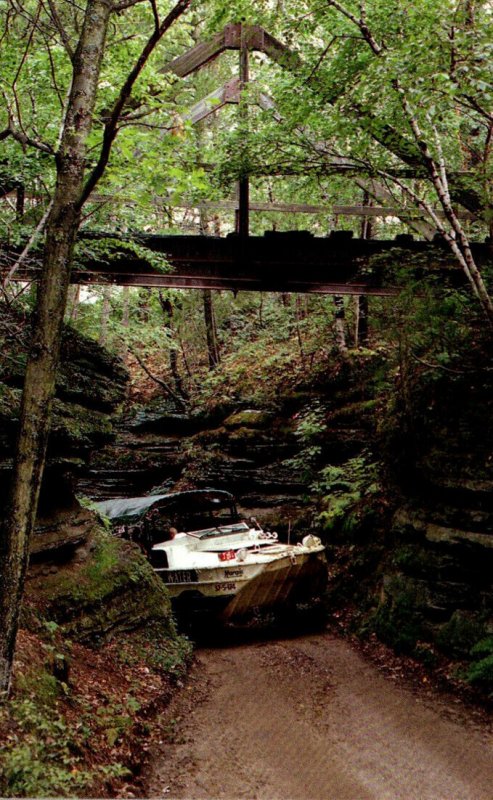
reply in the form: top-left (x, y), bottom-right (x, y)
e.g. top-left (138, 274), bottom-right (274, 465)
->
top-left (3, 231), bottom-right (486, 295)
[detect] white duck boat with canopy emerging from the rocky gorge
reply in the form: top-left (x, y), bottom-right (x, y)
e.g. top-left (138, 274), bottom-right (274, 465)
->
top-left (97, 490), bottom-right (327, 619)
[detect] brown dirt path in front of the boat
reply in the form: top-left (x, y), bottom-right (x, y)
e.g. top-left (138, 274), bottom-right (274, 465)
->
top-left (146, 634), bottom-right (493, 800)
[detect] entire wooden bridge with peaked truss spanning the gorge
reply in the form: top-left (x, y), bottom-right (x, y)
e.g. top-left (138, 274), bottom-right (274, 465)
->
top-left (0, 23), bottom-right (493, 295)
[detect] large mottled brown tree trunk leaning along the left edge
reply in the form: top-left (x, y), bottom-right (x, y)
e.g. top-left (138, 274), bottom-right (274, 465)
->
top-left (0, 0), bottom-right (111, 693)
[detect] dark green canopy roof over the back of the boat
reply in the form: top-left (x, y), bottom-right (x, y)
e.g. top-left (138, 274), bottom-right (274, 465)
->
top-left (94, 489), bottom-right (236, 525)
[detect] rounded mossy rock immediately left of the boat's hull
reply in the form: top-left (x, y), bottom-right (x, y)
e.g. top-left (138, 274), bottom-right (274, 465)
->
top-left (28, 529), bottom-right (175, 644)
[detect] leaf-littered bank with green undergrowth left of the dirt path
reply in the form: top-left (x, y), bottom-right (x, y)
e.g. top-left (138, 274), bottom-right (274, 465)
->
top-left (0, 623), bottom-right (191, 797)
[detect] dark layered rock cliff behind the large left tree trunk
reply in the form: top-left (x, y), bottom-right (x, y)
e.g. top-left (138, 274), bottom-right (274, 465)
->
top-left (0, 306), bottom-right (128, 556)
